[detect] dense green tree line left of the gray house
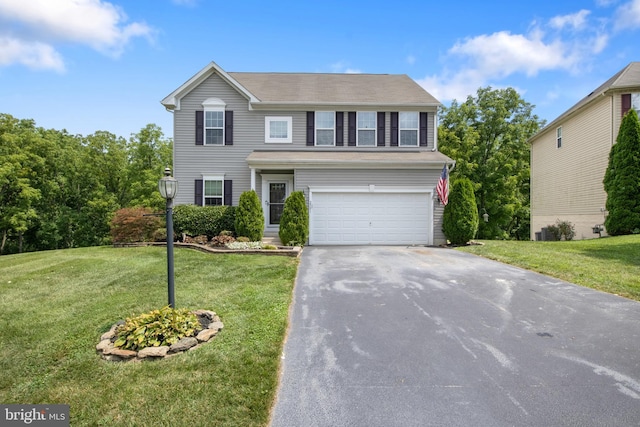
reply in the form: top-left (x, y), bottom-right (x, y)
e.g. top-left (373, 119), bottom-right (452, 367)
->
top-left (0, 113), bottom-right (173, 254)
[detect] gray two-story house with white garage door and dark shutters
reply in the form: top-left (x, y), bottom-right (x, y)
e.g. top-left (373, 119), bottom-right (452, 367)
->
top-left (162, 62), bottom-right (454, 245)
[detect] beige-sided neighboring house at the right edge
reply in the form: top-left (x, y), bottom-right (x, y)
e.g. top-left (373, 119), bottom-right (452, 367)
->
top-left (529, 62), bottom-right (640, 240)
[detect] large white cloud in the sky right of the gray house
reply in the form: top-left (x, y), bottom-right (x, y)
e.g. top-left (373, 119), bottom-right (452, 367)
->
top-left (418, 7), bottom-right (616, 102)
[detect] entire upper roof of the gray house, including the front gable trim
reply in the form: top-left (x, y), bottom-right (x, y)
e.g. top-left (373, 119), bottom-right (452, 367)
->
top-left (161, 62), bottom-right (441, 109)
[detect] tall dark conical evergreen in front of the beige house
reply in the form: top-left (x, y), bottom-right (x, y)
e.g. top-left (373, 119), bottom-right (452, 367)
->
top-left (603, 109), bottom-right (640, 236)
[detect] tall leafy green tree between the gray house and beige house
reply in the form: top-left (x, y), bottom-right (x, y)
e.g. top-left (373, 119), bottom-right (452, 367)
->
top-left (438, 87), bottom-right (544, 239)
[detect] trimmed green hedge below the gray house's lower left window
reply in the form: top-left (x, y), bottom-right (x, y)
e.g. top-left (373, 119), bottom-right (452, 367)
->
top-left (173, 205), bottom-right (235, 239)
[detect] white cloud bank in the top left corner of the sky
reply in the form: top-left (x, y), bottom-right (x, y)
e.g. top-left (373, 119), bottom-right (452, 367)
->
top-left (0, 0), bottom-right (154, 69)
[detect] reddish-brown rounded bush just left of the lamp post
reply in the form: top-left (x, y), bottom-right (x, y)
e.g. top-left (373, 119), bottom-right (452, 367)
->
top-left (110, 208), bottom-right (161, 243)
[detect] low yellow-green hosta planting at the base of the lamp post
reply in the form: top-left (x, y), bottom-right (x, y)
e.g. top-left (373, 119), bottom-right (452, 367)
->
top-left (113, 306), bottom-right (201, 351)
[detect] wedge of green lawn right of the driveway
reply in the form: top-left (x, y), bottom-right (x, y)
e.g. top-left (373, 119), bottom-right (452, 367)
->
top-left (459, 235), bottom-right (640, 301)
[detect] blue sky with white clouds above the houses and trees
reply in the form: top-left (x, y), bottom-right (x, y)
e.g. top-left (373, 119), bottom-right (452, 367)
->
top-left (0, 0), bottom-right (640, 138)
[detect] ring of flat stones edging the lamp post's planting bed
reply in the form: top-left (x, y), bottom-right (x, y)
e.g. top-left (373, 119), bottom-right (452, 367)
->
top-left (96, 310), bottom-right (224, 362)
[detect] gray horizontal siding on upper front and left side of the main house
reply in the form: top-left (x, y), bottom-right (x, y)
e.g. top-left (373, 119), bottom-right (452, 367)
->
top-left (173, 74), bottom-right (440, 207)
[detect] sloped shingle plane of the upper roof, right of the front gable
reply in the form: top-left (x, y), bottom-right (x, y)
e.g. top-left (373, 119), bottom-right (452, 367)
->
top-left (228, 72), bottom-right (440, 106)
